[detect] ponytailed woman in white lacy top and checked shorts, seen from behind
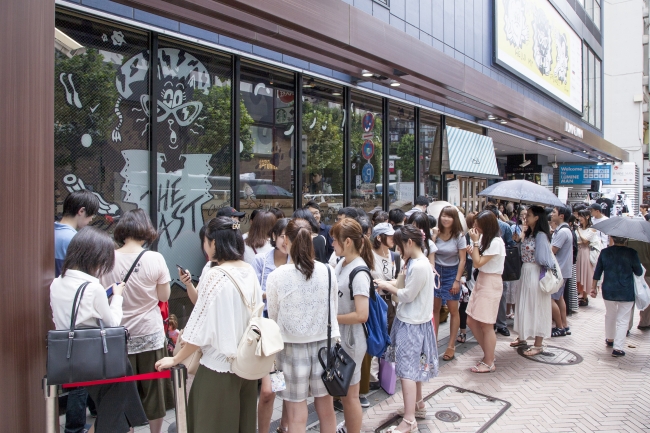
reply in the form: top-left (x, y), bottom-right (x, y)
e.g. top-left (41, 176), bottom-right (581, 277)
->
top-left (268, 219), bottom-right (340, 432)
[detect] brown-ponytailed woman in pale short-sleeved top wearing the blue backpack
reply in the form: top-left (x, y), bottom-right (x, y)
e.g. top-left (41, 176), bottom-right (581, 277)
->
top-left (331, 218), bottom-right (375, 433)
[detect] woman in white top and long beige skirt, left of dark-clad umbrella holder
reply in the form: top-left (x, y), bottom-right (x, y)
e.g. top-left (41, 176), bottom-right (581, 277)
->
top-left (576, 209), bottom-right (602, 307)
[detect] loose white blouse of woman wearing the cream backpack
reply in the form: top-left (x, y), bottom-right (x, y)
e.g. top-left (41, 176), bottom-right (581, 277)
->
top-left (183, 266), bottom-right (262, 373)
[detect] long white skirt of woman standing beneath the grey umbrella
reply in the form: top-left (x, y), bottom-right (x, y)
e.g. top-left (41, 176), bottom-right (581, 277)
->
top-left (513, 263), bottom-right (552, 340)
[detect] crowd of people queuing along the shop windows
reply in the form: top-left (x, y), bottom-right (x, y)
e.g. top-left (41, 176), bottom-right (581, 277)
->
top-left (51, 190), bottom-right (650, 433)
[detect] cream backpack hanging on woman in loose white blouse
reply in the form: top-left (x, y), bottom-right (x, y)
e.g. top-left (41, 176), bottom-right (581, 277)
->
top-left (219, 266), bottom-right (284, 380)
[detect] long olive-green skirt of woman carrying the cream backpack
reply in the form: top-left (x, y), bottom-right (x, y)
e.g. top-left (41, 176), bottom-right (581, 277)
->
top-left (187, 365), bottom-right (257, 433)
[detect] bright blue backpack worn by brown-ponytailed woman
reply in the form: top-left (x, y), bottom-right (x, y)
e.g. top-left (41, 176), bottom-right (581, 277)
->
top-left (348, 266), bottom-right (390, 358)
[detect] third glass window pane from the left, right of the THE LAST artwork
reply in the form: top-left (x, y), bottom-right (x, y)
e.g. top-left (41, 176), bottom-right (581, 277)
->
top-left (239, 62), bottom-right (295, 231)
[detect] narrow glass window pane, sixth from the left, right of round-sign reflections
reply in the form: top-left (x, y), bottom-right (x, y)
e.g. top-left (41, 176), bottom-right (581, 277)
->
top-left (388, 104), bottom-right (415, 210)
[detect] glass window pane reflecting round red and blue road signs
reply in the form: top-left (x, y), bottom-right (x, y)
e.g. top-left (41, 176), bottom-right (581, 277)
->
top-left (350, 92), bottom-right (384, 212)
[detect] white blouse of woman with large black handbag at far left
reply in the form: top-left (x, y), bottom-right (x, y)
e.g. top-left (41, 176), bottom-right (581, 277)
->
top-left (50, 269), bottom-right (123, 330)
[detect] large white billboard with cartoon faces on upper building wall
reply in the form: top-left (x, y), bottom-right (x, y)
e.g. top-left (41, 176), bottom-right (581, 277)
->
top-left (494, 0), bottom-right (583, 113)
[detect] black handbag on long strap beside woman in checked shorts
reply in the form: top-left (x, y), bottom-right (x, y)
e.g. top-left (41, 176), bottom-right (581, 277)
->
top-left (318, 266), bottom-right (357, 397)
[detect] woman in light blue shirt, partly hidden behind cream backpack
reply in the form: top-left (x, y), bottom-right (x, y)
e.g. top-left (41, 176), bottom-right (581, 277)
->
top-left (253, 218), bottom-right (291, 431)
